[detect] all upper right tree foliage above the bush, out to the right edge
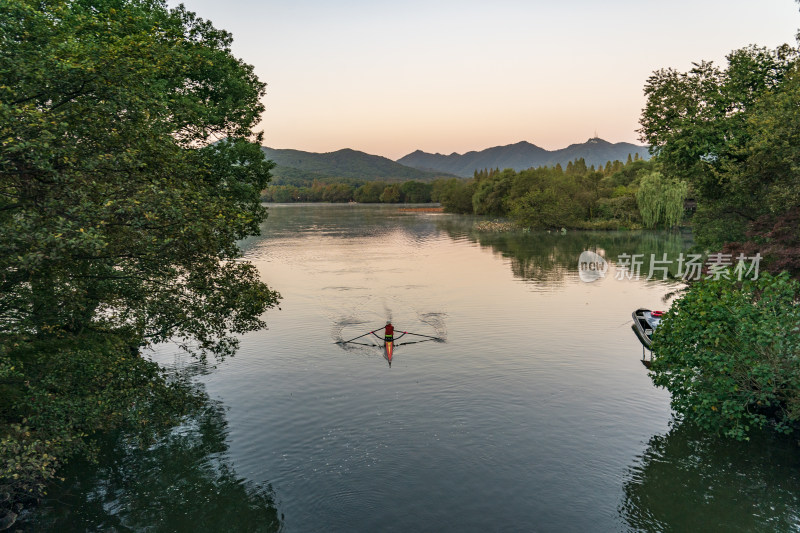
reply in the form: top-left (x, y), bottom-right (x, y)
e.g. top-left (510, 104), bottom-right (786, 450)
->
top-left (639, 45), bottom-right (800, 249)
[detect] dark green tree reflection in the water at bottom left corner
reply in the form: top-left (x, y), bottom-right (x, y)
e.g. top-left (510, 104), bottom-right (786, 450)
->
top-left (20, 376), bottom-right (281, 532)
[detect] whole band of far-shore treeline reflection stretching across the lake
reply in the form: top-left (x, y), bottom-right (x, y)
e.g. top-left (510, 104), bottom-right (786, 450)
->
top-left (252, 204), bottom-right (691, 284)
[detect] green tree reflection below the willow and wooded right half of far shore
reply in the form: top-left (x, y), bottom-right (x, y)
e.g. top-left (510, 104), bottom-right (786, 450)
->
top-left (437, 217), bottom-right (691, 284)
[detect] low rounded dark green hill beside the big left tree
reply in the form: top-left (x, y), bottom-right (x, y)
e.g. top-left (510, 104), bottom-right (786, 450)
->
top-left (261, 146), bottom-right (446, 184)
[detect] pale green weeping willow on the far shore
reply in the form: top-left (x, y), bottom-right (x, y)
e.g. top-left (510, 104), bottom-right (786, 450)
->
top-left (636, 172), bottom-right (688, 228)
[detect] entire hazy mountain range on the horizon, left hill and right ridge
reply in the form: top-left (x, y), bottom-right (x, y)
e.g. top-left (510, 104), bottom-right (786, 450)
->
top-left (262, 137), bottom-right (650, 185)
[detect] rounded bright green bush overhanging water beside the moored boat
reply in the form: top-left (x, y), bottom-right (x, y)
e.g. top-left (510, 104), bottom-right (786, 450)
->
top-left (651, 274), bottom-right (800, 439)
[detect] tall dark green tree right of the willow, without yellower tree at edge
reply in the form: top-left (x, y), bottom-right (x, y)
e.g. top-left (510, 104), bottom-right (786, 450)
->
top-left (639, 45), bottom-right (797, 249)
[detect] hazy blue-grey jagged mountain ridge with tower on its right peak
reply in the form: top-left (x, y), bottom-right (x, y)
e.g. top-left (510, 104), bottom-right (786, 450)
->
top-left (397, 137), bottom-right (650, 177)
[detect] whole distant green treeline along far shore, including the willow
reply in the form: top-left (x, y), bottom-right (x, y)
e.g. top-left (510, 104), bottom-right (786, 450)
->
top-left (262, 154), bottom-right (688, 228)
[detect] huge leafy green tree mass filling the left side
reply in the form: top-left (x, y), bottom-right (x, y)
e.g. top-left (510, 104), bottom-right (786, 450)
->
top-left (0, 0), bottom-right (279, 518)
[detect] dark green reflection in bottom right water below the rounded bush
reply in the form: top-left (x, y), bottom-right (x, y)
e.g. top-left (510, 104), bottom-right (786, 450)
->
top-left (619, 424), bottom-right (800, 532)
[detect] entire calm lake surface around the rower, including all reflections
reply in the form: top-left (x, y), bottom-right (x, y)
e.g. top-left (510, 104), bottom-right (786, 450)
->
top-left (28, 205), bottom-right (800, 532)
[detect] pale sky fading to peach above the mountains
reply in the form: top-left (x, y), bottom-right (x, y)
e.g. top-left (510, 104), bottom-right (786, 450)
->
top-left (170, 0), bottom-right (800, 159)
